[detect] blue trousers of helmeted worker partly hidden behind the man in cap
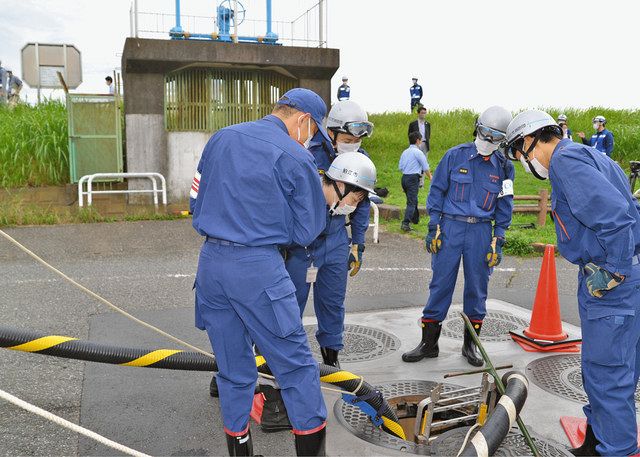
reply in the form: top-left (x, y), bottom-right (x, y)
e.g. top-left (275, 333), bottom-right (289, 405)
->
top-left (286, 224), bottom-right (349, 351)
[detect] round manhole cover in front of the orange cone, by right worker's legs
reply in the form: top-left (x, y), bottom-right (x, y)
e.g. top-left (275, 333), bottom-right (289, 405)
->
top-left (527, 354), bottom-right (640, 403)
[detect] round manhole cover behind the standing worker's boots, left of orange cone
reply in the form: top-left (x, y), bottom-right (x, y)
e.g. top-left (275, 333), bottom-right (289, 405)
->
top-left (442, 310), bottom-right (529, 341)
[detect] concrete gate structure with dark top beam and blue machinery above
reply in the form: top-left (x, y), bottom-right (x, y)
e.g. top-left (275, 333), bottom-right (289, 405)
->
top-left (122, 38), bottom-right (340, 202)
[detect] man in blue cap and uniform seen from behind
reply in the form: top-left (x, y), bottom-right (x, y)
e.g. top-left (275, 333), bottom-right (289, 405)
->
top-left (190, 89), bottom-right (328, 455)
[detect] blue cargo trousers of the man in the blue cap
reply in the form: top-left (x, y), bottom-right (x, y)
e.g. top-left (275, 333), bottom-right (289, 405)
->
top-left (196, 241), bottom-right (327, 434)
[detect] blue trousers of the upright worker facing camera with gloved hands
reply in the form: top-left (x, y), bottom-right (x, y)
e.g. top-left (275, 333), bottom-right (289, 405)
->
top-left (422, 218), bottom-right (493, 322)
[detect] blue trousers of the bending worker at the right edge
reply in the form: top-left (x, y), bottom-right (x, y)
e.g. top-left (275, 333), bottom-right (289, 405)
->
top-left (578, 265), bottom-right (640, 455)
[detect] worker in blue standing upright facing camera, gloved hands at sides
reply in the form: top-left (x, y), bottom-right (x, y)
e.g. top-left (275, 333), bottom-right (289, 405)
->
top-left (402, 106), bottom-right (514, 366)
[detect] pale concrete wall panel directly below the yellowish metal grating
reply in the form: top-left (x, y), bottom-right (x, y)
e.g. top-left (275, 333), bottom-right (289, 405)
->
top-left (167, 132), bottom-right (211, 201)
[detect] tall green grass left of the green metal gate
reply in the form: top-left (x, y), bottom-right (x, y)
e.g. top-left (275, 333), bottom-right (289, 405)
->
top-left (0, 101), bottom-right (69, 188)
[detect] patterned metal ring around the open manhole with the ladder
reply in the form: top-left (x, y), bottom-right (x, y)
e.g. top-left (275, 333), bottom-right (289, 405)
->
top-left (333, 381), bottom-right (460, 455)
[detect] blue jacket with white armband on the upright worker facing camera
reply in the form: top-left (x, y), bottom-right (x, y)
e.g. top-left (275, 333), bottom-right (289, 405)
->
top-left (427, 143), bottom-right (514, 237)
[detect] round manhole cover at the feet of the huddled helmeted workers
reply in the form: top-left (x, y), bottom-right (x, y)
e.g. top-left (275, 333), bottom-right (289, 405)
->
top-left (304, 324), bottom-right (400, 362)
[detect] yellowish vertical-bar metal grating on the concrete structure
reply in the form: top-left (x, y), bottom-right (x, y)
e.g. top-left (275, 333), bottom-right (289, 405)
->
top-left (164, 68), bottom-right (297, 132)
